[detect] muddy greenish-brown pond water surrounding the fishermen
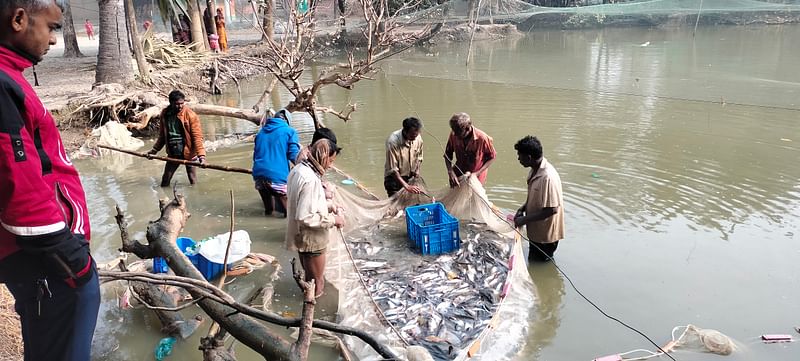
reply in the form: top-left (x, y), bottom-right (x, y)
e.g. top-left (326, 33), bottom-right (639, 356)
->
top-left (83, 25), bottom-right (800, 360)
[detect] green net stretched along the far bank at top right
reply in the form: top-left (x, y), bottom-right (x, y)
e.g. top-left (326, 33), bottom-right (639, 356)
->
top-left (340, 0), bottom-right (800, 31)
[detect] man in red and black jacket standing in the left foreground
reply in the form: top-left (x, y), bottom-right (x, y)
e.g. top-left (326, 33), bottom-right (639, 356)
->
top-left (0, 0), bottom-right (100, 361)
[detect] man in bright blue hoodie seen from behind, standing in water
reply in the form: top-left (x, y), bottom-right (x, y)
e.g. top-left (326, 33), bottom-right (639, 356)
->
top-left (253, 109), bottom-right (300, 216)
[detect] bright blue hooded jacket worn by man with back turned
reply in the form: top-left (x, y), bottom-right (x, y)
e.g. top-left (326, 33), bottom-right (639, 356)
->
top-left (253, 113), bottom-right (300, 184)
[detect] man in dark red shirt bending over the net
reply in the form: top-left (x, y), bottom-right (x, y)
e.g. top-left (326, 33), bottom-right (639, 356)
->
top-left (444, 113), bottom-right (497, 188)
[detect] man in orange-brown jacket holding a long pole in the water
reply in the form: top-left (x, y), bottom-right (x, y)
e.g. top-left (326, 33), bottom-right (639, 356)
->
top-left (147, 90), bottom-right (206, 187)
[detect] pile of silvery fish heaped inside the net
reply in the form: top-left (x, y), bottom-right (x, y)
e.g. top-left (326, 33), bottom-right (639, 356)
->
top-left (350, 224), bottom-right (513, 360)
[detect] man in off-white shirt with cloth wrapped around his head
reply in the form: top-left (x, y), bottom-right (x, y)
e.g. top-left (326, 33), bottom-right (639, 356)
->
top-left (286, 139), bottom-right (344, 298)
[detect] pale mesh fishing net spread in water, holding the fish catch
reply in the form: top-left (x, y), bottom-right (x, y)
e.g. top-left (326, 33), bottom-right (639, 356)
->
top-left (326, 176), bottom-right (534, 360)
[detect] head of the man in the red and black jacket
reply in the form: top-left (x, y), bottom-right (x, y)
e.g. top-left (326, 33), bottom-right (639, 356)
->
top-left (0, 0), bottom-right (61, 62)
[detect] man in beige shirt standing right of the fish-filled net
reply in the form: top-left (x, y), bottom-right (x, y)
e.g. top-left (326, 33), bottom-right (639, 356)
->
top-left (514, 136), bottom-right (564, 262)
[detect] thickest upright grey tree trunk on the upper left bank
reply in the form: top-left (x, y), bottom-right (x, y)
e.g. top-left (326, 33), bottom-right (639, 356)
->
top-left (95, 0), bottom-right (133, 84)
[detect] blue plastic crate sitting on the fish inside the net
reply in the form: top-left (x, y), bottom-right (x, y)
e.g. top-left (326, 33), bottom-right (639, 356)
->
top-left (405, 202), bottom-right (461, 254)
